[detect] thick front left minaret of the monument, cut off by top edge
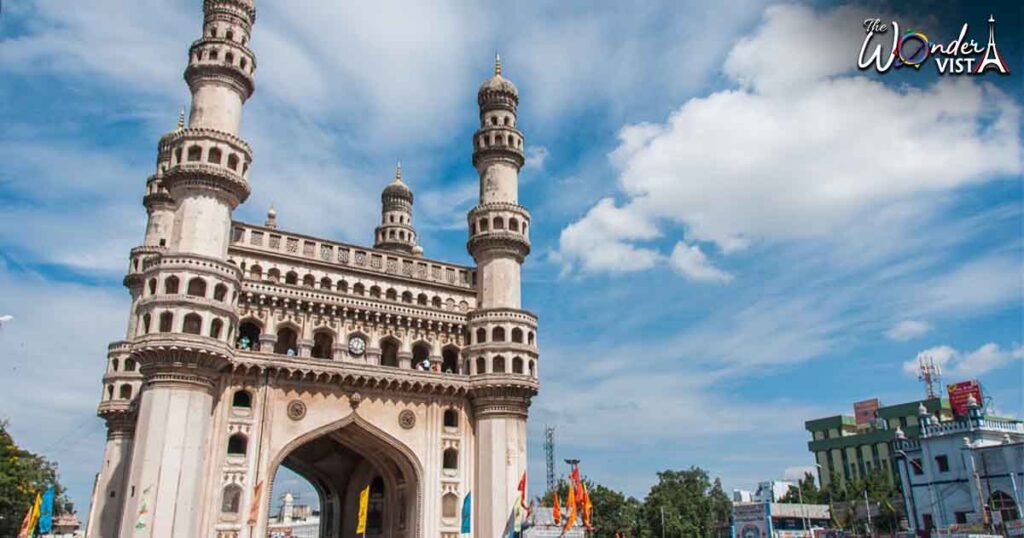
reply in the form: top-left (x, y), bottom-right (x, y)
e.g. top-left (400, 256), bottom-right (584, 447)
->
top-left (120, 0), bottom-right (256, 537)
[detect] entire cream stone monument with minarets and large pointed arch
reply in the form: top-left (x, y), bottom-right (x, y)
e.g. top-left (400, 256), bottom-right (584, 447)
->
top-left (88, 0), bottom-right (539, 538)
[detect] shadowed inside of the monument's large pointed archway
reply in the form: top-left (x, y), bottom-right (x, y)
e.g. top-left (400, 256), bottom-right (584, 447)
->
top-left (263, 414), bottom-right (423, 538)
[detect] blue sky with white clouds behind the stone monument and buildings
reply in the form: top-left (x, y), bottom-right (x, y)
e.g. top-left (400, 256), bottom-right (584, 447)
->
top-left (0, 0), bottom-right (1024, 513)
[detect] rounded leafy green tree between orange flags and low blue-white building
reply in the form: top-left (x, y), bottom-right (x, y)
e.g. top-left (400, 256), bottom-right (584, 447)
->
top-left (642, 467), bottom-right (732, 538)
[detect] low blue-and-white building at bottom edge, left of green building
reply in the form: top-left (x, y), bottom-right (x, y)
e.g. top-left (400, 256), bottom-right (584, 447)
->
top-left (731, 502), bottom-right (831, 538)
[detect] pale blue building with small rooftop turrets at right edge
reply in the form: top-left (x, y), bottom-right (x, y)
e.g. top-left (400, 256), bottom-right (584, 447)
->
top-left (893, 396), bottom-right (1024, 531)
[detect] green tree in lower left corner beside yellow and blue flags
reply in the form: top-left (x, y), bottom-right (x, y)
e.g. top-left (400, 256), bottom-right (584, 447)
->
top-left (0, 421), bottom-right (74, 536)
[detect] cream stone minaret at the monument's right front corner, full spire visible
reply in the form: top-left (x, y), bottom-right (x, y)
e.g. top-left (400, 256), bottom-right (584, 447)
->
top-left (463, 53), bottom-right (538, 536)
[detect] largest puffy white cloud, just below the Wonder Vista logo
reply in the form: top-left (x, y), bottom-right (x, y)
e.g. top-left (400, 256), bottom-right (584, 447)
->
top-left (559, 5), bottom-right (1021, 278)
